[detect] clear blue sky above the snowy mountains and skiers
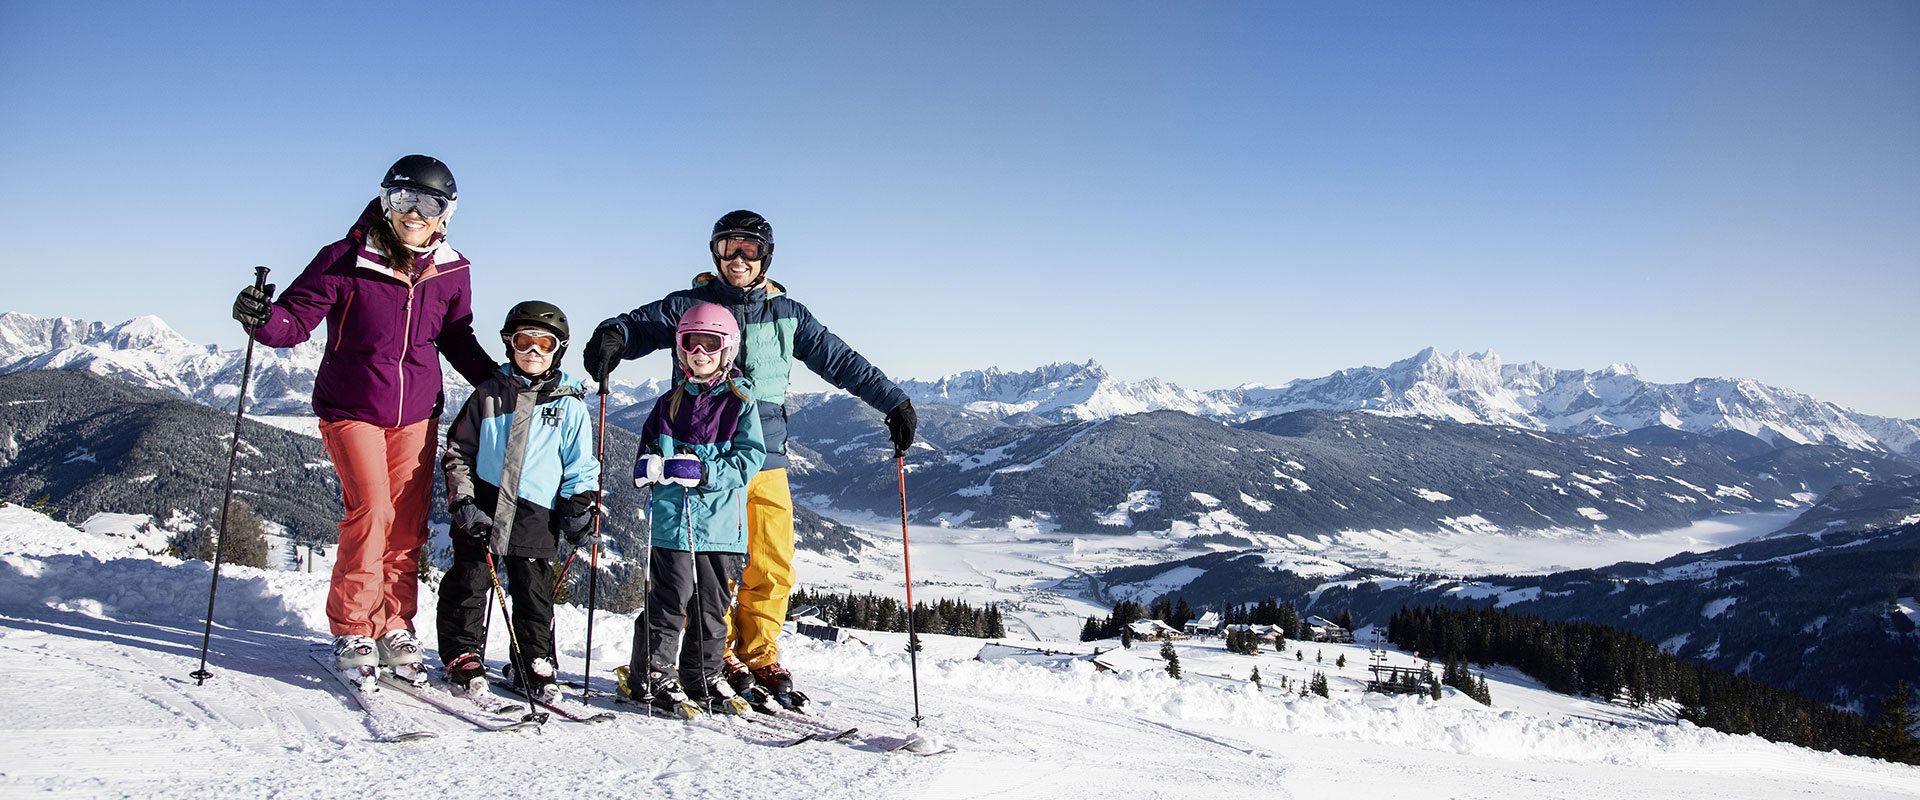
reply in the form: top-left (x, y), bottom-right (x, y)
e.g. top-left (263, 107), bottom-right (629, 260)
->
top-left (0, 0), bottom-right (1920, 418)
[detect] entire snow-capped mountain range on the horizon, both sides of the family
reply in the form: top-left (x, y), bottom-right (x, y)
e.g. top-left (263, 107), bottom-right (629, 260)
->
top-left (0, 313), bottom-right (1920, 457)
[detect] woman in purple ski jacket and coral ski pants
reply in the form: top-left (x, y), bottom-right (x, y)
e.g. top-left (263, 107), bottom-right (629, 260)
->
top-left (234, 155), bottom-right (495, 681)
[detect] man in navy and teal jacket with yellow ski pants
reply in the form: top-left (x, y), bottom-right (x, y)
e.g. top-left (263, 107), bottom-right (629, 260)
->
top-left (584, 211), bottom-right (916, 694)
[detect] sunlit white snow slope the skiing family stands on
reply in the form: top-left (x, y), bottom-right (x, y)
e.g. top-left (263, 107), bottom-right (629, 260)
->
top-left (0, 505), bottom-right (1920, 800)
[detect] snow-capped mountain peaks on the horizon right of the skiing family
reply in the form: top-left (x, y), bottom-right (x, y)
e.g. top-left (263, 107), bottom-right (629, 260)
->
top-left (900, 347), bottom-right (1920, 455)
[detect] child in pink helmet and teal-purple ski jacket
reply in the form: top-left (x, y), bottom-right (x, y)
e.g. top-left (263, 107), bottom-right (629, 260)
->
top-left (624, 303), bottom-right (766, 716)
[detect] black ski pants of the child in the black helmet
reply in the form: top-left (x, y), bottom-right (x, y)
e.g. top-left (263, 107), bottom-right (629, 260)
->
top-left (436, 535), bottom-right (553, 671)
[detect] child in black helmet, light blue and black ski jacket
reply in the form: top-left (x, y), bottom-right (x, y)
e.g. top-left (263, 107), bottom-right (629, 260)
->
top-left (438, 299), bottom-right (599, 702)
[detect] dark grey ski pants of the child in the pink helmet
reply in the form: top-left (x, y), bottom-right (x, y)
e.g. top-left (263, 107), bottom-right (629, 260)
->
top-left (628, 547), bottom-right (747, 685)
